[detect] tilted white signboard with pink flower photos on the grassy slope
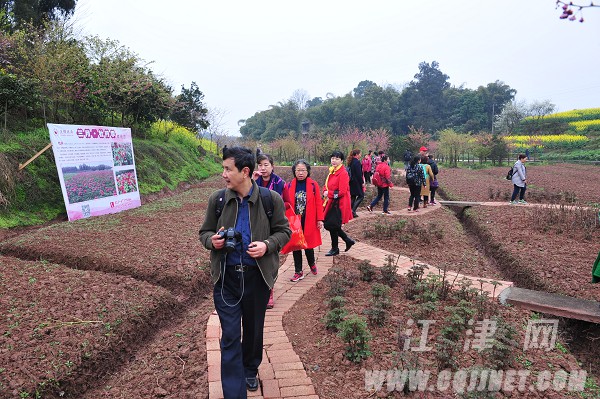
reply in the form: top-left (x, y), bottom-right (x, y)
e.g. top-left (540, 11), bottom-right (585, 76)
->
top-left (48, 123), bottom-right (141, 220)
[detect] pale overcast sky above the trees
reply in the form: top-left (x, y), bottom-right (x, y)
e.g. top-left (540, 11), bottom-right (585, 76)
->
top-left (75, 0), bottom-right (600, 135)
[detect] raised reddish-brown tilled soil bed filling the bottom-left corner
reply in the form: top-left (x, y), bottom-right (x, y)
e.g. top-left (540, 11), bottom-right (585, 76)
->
top-left (0, 257), bottom-right (176, 398)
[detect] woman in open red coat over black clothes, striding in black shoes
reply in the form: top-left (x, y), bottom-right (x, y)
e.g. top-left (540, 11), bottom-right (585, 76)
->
top-left (323, 151), bottom-right (355, 256)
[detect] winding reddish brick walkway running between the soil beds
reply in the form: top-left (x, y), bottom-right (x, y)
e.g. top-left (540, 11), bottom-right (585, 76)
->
top-left (206, 206), bottom-right (512, 399)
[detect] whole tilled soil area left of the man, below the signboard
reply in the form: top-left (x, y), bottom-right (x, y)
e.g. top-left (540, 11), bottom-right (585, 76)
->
top-left (0, 177), bottom-right (223, 398)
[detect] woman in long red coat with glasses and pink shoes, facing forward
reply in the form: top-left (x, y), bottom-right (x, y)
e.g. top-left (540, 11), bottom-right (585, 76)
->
top-left (282, 159), bottom-right (323, 282)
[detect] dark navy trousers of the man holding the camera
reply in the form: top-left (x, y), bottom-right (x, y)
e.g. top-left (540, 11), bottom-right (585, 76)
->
top-left (213, 266), bottom-right (270, 399)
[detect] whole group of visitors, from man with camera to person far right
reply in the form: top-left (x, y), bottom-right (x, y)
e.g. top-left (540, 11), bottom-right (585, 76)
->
top-left (199, 147), bottom-right (540, 398)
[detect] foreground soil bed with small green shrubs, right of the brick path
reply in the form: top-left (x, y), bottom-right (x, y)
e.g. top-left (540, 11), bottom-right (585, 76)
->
top-left (284, 256), bottom-right (591, 399)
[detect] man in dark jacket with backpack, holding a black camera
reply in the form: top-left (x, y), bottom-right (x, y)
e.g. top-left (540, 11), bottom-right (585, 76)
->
top-left (199, 147), bottom-right (291, 398)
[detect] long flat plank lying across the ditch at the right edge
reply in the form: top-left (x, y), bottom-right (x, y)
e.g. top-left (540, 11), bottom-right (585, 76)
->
top-left (499, 287), bottom-right (600, 324)
